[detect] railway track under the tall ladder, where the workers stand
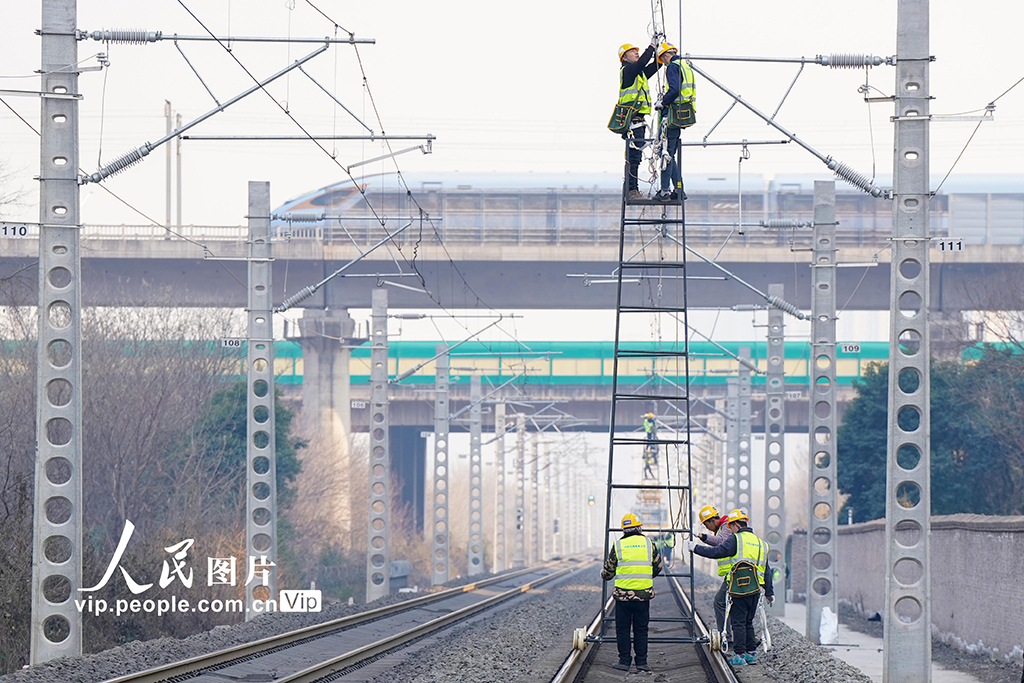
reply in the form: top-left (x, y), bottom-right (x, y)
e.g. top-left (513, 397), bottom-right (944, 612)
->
top-left (550, 577), bottom-right (738, 683)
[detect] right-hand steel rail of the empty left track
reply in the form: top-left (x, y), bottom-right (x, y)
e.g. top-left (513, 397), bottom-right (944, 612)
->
top-left (275, 561), bottom-right (591, 683)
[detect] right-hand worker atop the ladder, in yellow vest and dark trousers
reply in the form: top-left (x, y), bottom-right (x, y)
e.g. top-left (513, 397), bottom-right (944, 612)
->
top-left (654, 43), bottom-right (696, 202)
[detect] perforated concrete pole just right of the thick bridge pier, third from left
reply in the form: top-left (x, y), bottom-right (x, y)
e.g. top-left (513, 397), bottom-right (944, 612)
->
top-left (367, 288), bottom-right (391, 602)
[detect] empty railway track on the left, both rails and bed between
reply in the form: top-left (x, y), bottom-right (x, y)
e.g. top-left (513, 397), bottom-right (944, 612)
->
top-left (105, 560), bottom-right (593, 683)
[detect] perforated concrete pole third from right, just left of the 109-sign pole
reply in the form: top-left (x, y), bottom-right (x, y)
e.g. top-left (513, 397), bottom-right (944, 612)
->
top-left (762, 285), bottom-right (785, 616)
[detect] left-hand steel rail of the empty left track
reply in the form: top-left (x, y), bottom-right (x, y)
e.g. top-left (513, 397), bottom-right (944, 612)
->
top-left (103, 561), bottom-right (571, 683)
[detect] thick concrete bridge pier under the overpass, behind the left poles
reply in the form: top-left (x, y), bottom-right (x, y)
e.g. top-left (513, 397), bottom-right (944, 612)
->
top-left (298, 308), bottom-right (356, 549)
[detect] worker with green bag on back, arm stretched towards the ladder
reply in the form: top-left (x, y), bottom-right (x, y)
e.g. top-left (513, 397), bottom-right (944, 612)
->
top-left (686, 509), bottom-right (775, 667)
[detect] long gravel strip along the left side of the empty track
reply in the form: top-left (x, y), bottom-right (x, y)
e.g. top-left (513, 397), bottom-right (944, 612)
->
top-left (0, 574), bottom-right (492, 683)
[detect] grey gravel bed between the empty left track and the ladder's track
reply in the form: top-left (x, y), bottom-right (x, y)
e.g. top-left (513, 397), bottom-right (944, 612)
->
top-left (370, 567), bottom-right (601, 683)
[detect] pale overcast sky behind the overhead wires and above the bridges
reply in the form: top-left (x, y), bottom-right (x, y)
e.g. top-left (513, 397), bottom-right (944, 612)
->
top-left (0, 0), bottom-right (1024, 339)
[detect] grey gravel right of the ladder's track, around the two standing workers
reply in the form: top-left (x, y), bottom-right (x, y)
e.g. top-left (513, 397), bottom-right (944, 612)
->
top-left (694, 574), bottom-right (871, 683)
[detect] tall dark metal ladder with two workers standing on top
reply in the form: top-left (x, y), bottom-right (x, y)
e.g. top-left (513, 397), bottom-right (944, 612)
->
top-left (593, 140), bottom-right (698, 643)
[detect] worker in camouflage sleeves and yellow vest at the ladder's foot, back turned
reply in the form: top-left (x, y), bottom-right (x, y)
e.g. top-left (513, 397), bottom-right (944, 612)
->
top-left (601, 512), bottom-right (662, 671)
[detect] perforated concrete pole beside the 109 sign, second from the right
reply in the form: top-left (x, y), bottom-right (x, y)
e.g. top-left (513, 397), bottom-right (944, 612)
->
top-left (807, 180), bottom-right (838, 643)
